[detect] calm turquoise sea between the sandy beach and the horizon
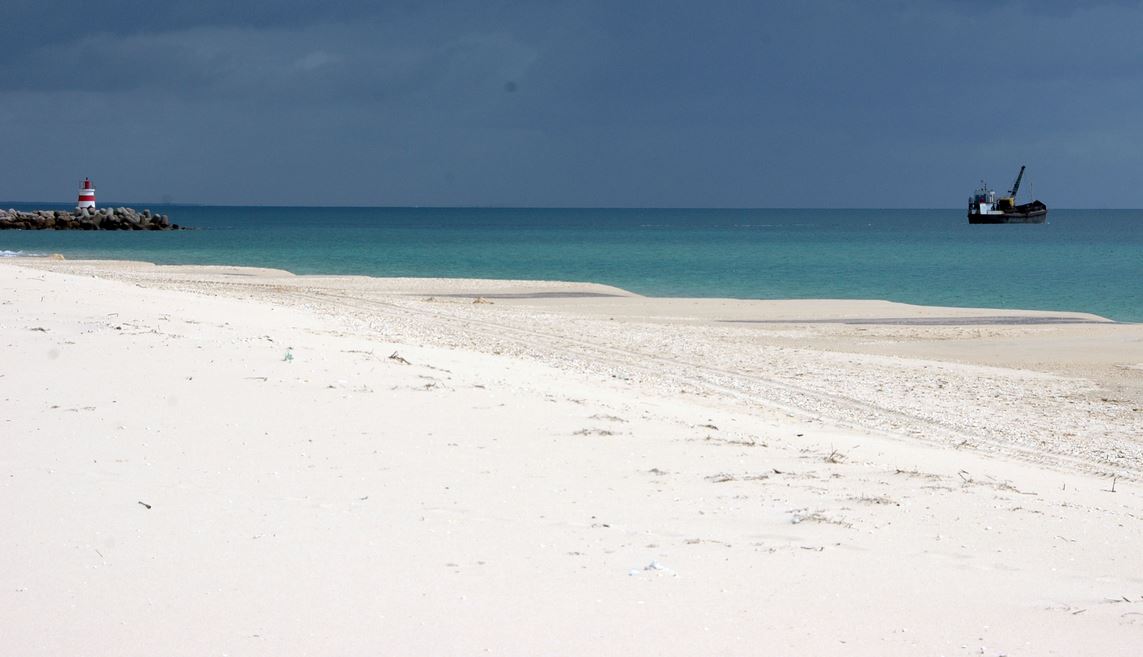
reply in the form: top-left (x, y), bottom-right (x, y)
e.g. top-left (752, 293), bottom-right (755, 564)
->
top-left (0, 203), bottom-right (1143, 321)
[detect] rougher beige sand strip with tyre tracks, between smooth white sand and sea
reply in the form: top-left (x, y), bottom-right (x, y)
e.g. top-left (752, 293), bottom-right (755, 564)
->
top-left (17, 261), bottom-right (1143, 478)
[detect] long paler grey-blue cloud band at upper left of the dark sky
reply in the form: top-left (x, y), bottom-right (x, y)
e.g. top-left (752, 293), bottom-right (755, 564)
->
top-left (0, 25), bottom-right (530, 101)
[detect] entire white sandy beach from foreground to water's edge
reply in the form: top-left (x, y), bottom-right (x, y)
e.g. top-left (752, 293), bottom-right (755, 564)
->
top-left (0, 258), bottom-right (1143, 656)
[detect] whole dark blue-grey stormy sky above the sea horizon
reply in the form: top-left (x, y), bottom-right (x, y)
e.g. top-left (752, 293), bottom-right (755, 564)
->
top-left (0, 0), bottom-right (1143, 208)
